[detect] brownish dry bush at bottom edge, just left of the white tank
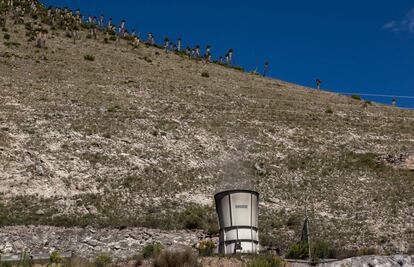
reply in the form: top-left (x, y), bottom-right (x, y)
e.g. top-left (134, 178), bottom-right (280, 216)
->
top-left (154, 249), bottom-right (199, 267)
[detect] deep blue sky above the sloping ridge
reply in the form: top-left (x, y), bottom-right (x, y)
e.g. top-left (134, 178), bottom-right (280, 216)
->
top-left (42, 0), bottom-right (414, 108)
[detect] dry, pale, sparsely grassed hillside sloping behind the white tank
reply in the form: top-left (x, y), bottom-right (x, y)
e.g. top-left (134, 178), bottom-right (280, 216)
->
top-left (0, 1), bottom-right (414, 258)
